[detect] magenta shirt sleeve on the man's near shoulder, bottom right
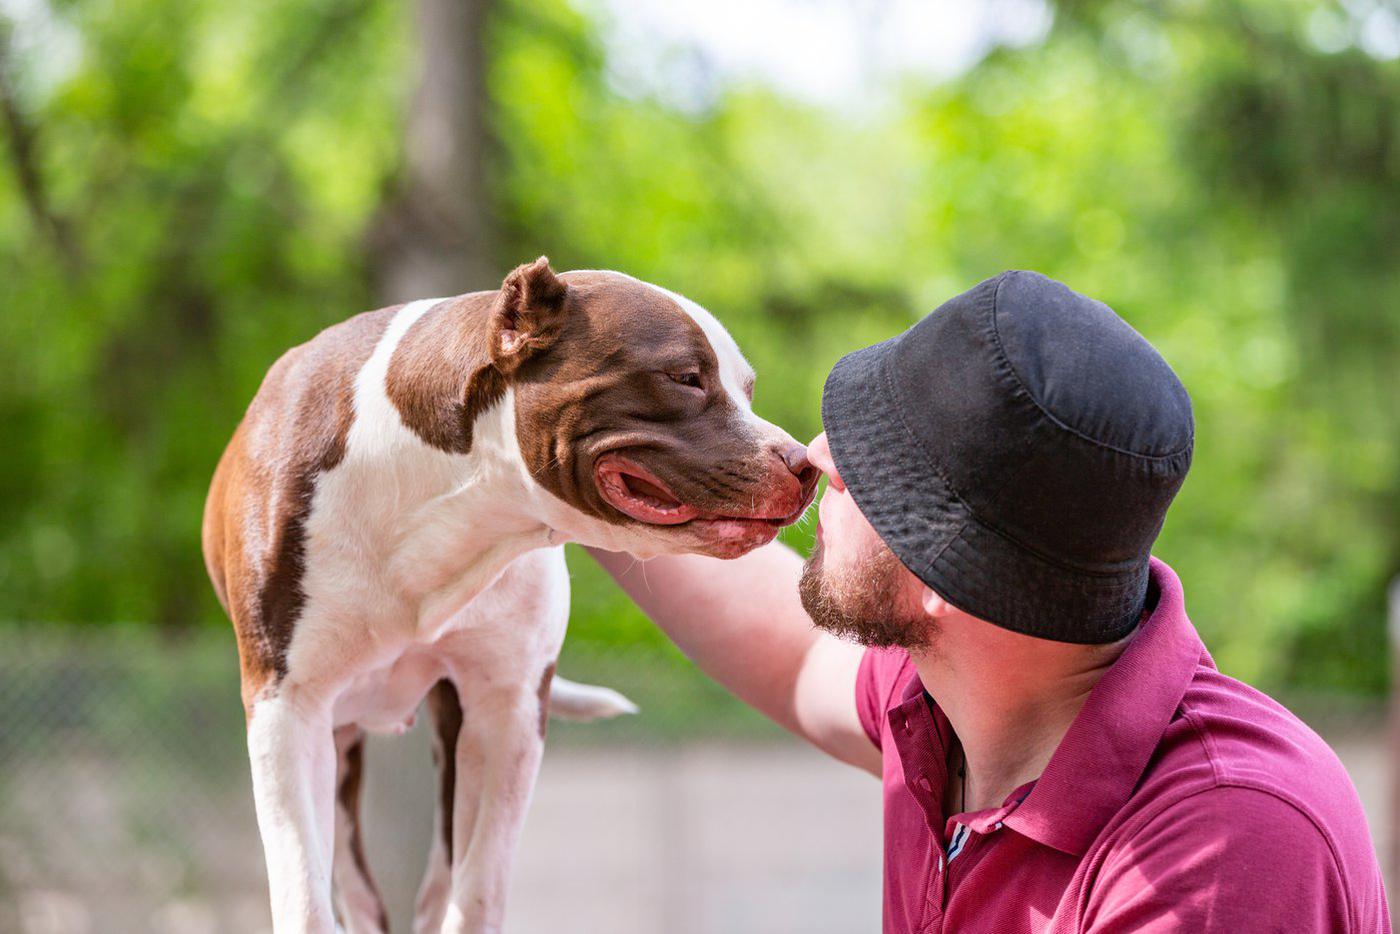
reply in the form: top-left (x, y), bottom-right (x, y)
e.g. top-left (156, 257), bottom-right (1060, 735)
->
top-left (1084, 787), bottom-right (1371, 934)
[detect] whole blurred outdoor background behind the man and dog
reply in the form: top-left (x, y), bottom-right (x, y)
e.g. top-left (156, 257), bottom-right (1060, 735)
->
top-left (0, 0), bottom-right (1400, 934)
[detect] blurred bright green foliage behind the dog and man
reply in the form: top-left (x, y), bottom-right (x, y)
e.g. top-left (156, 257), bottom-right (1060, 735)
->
top-left (0, 0), bottom-right (1400, 693)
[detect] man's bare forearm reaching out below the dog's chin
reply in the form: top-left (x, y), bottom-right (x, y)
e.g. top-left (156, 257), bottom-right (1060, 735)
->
top-left (589, 542), bottom-right (818, 732)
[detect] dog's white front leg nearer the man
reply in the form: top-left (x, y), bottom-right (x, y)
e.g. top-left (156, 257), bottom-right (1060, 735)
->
top-left (442, 665), bottom-right (553, 934)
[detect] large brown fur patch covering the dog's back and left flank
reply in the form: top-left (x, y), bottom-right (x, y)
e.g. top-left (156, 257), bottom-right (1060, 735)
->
top-left (203, 305), bottom-right (400, 710)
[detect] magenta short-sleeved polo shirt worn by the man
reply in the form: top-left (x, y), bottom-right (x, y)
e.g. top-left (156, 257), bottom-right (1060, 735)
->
top-left (855, 559), bottom-right (1390, 934)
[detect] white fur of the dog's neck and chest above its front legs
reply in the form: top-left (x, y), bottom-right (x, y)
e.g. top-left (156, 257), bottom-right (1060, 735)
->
top-left (273, 299), bottom-right (568, 730)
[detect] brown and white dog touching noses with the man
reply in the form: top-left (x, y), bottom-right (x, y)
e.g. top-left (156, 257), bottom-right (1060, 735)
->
top-left (203, 258), bottom-right (816, 931)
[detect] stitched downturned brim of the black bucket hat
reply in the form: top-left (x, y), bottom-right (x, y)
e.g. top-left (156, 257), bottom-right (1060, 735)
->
top-left (822, 335), bottom-right (1148, 644)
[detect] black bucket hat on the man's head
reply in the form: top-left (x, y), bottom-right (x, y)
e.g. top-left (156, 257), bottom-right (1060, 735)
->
top-left (822, 272), bottom-right (1194, 643)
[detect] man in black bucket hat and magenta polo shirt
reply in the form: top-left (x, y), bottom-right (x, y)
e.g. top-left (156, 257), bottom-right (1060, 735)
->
top-left (596, 272), bottom-right (1390, 934)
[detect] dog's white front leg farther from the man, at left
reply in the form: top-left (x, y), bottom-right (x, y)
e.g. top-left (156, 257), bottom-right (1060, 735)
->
top-left (248, 683), bottom-right (336, 934)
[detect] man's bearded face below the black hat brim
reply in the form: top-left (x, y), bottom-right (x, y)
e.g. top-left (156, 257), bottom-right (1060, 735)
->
top-left (798, 433), bottom-right (932, 650)
